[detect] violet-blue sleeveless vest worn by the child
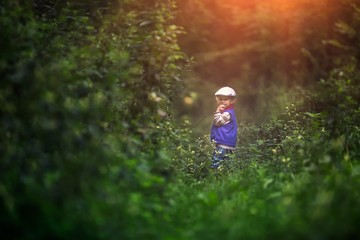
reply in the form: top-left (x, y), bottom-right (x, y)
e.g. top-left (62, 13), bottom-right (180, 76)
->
top-left (210, 108), bottom-right (237, 147)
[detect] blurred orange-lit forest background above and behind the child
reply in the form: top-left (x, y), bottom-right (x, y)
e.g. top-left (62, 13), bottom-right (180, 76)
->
top-left (176, 0), bottom-right (358, 129)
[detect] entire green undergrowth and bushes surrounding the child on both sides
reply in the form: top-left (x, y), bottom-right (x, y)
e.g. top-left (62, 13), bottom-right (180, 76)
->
top-left (0, 1), bottom-right (360, 239)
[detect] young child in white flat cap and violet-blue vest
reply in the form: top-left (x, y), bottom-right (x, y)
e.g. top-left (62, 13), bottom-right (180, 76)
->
top-left (210, 87), bottom-right (237, 168)
